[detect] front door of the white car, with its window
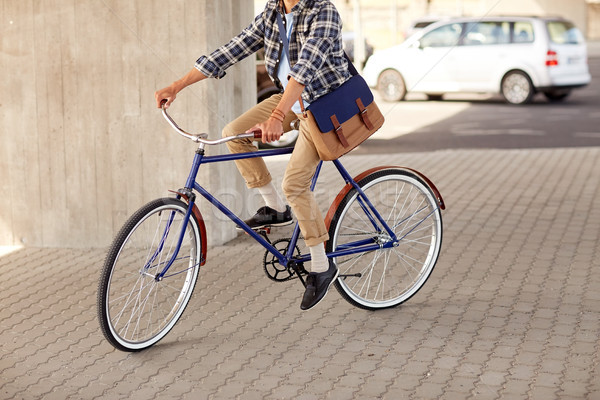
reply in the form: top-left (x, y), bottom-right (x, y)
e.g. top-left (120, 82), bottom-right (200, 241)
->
top-left (406, 22), bottom-right (463, 93)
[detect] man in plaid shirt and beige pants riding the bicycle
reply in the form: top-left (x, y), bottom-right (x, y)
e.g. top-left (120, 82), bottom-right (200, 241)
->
top-left (155, 0), bottom-right (351, 310)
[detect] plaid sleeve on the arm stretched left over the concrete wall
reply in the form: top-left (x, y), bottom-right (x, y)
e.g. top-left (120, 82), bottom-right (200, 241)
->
top-left (194, 12), bottom-right (264, 79)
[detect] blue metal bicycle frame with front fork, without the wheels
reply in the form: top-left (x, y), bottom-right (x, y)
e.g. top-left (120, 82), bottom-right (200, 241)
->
top-left (156, 145), bottom-right (398, 280)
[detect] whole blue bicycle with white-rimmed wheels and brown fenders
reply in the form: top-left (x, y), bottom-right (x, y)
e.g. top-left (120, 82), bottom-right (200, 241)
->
top-left (97, 102), bottom-right (445, 351)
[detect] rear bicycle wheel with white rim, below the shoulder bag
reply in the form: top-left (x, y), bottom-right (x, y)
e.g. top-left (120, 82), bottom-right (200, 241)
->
top-left (326, 169), bottom-right (442, 310)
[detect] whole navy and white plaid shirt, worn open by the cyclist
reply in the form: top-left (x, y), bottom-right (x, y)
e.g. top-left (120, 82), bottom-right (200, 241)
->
top-left (195, 0), bottom-right (351, 103)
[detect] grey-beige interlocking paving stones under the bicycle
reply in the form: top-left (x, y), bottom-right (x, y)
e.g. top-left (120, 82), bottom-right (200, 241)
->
top-left (0, 148), bottom-right (600, 400)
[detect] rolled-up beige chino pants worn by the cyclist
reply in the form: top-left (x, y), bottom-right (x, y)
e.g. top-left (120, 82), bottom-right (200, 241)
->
top-left (223, 94), bottom-right (329, 246)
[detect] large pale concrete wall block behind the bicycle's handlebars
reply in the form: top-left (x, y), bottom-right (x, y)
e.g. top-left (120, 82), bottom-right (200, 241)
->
top-left (0, 0), bottom-right (256, 247)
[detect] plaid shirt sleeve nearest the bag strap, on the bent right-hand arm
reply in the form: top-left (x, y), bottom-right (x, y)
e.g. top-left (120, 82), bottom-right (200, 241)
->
top-left (290, 5), bottom-right (342, 86)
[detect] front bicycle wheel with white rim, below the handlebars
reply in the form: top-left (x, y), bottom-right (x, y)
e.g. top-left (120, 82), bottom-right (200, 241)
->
top-left (98, 198), bottom-right (202, 351)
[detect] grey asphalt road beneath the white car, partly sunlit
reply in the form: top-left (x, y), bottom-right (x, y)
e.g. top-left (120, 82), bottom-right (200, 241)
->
top-left (355, 58), bottom-right (600, 154)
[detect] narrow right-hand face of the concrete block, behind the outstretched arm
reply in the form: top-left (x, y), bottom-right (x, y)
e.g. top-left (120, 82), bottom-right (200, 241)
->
top-left (194, 0), bottom-right (256, 244)
